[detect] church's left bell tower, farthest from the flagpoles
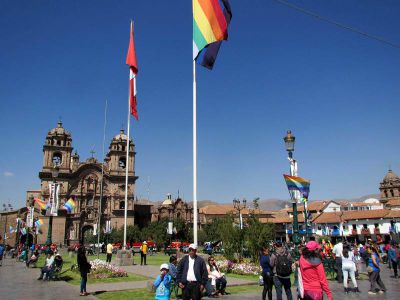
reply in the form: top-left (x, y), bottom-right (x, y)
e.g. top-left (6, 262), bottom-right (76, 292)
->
top-left (42, 121), bottom-right (73, 173)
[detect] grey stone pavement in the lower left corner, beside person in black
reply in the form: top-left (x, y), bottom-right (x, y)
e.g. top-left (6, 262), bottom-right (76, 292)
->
top-left (0, 257), bottom-right (97, 300)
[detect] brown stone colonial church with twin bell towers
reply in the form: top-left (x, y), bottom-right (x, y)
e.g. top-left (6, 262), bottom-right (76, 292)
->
top-left (26, 122), bottom-right (151, 244)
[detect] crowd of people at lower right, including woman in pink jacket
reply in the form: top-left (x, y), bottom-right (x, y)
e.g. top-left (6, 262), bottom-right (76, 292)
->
top-left (260, 238), bottom-right (400, 300)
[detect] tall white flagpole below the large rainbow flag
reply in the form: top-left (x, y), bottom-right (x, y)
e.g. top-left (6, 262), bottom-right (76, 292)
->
top-left (193, 60), bottom-right (197, 245)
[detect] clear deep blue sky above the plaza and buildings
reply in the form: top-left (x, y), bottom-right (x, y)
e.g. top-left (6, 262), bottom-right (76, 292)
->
top-left (0, 0), bottom-right (400, 206)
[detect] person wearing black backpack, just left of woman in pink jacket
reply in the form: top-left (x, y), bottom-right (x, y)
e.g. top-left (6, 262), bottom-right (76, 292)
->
top-left (270, 242), bottom-right (293, 300)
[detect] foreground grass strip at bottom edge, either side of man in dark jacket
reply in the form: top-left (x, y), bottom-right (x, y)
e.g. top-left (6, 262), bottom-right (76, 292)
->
top-left (96, 285), bottom-right (262, 300)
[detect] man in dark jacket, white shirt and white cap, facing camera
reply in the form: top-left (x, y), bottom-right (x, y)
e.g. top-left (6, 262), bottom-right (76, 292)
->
top-left (176, 244), bottom-right (208, 300)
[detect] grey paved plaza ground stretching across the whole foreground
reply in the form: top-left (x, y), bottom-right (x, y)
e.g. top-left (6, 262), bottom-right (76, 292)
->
top-left (0, 258), bottom-right (400, 300)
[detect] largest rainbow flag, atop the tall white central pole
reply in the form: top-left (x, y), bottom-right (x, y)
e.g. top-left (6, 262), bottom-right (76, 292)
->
top-left (193, 0), bottom-right (232, 70)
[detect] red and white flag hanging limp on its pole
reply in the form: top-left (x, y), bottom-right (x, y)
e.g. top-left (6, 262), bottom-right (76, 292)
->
top-left (126, 21), bottom-right (138, 120)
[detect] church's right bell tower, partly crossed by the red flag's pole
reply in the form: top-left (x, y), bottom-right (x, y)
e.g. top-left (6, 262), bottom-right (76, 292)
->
top-left (107, 129), bottom-right (136, 176)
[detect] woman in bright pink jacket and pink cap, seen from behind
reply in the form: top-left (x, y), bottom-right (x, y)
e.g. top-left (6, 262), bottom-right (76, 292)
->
top-left (300, 241), bottom-right (332, 300)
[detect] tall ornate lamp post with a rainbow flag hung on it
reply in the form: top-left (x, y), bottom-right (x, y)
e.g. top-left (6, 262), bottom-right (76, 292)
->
top-left (283, 130), bottom-right (300, 260)
